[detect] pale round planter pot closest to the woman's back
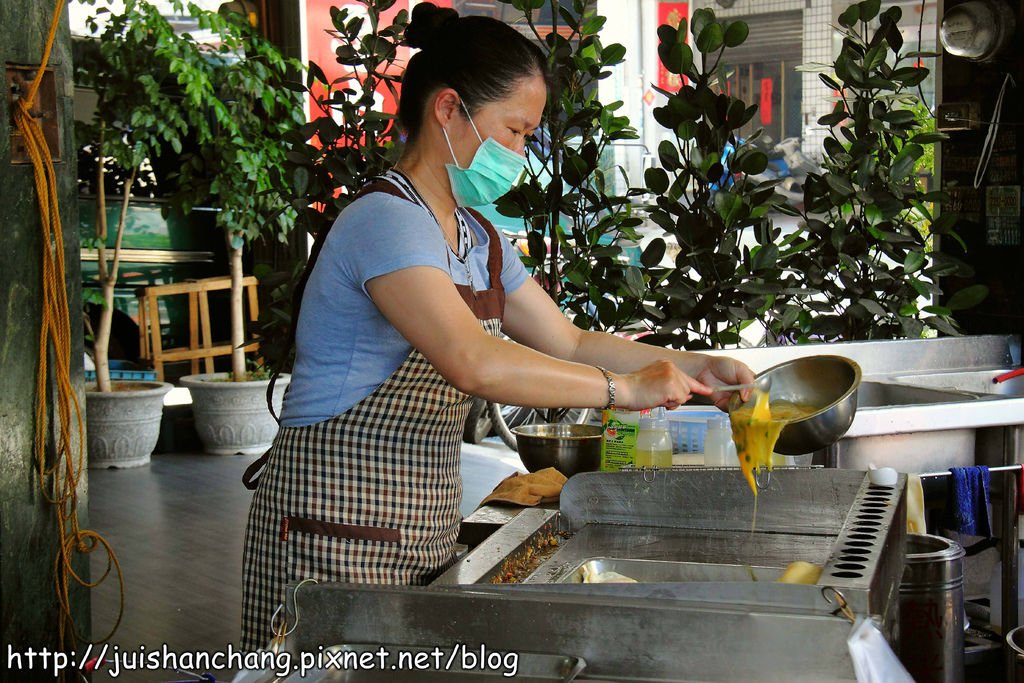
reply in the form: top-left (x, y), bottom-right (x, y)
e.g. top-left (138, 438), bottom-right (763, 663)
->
top-left (180, 373), bottom-right (291, 456)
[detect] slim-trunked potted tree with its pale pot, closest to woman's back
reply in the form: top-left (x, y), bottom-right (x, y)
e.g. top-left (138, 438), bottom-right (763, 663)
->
top-left (175, 5), bottom-right (303, 455)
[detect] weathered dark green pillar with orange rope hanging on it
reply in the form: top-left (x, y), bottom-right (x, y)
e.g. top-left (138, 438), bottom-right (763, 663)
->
top-left (0, 0), bottom-right (89, 681)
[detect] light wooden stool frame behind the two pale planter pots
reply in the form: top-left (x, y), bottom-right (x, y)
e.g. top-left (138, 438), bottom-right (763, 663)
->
top-left (136, 275), bottom-right (259, 382)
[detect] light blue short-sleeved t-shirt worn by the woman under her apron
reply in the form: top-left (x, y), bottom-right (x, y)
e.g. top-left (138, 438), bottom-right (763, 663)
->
top-left (281, 193), bottom-right (527, 427)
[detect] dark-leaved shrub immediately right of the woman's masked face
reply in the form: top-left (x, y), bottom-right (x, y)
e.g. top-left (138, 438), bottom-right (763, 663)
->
top-left (497, 0), bottom-right (643, 331)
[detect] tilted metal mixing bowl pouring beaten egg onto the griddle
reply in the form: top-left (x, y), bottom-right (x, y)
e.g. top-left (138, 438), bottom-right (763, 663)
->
top-left (729, 355), bottom-right (860, 456)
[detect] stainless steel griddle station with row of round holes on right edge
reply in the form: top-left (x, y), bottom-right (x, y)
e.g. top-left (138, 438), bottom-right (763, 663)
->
top-left (278, 468), bottom-right (906, 681)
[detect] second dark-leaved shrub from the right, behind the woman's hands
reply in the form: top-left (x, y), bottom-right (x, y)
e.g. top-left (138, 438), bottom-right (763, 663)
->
top-left (641, 9), bottom-right (808, 348)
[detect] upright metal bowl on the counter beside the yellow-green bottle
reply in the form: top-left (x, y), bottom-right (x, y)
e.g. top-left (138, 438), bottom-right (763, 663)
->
top-left (512, 424), bottom-right (603, 477)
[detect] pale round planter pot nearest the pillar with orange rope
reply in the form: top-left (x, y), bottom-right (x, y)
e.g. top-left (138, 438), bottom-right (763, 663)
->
top-left (85, 382), bottom-right (173, 469)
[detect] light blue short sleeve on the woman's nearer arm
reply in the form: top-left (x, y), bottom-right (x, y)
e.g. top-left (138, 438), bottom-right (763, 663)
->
top-left (328, 193), bottom-right (449, 296)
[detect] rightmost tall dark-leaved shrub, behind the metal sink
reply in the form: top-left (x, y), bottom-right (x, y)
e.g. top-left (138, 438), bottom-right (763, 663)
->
top-left (786, 0), bottom-right (987, 340)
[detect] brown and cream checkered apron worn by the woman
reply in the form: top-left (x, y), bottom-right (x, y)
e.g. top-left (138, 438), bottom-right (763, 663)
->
top-left (242, 180), bottom-right (505, 651)
